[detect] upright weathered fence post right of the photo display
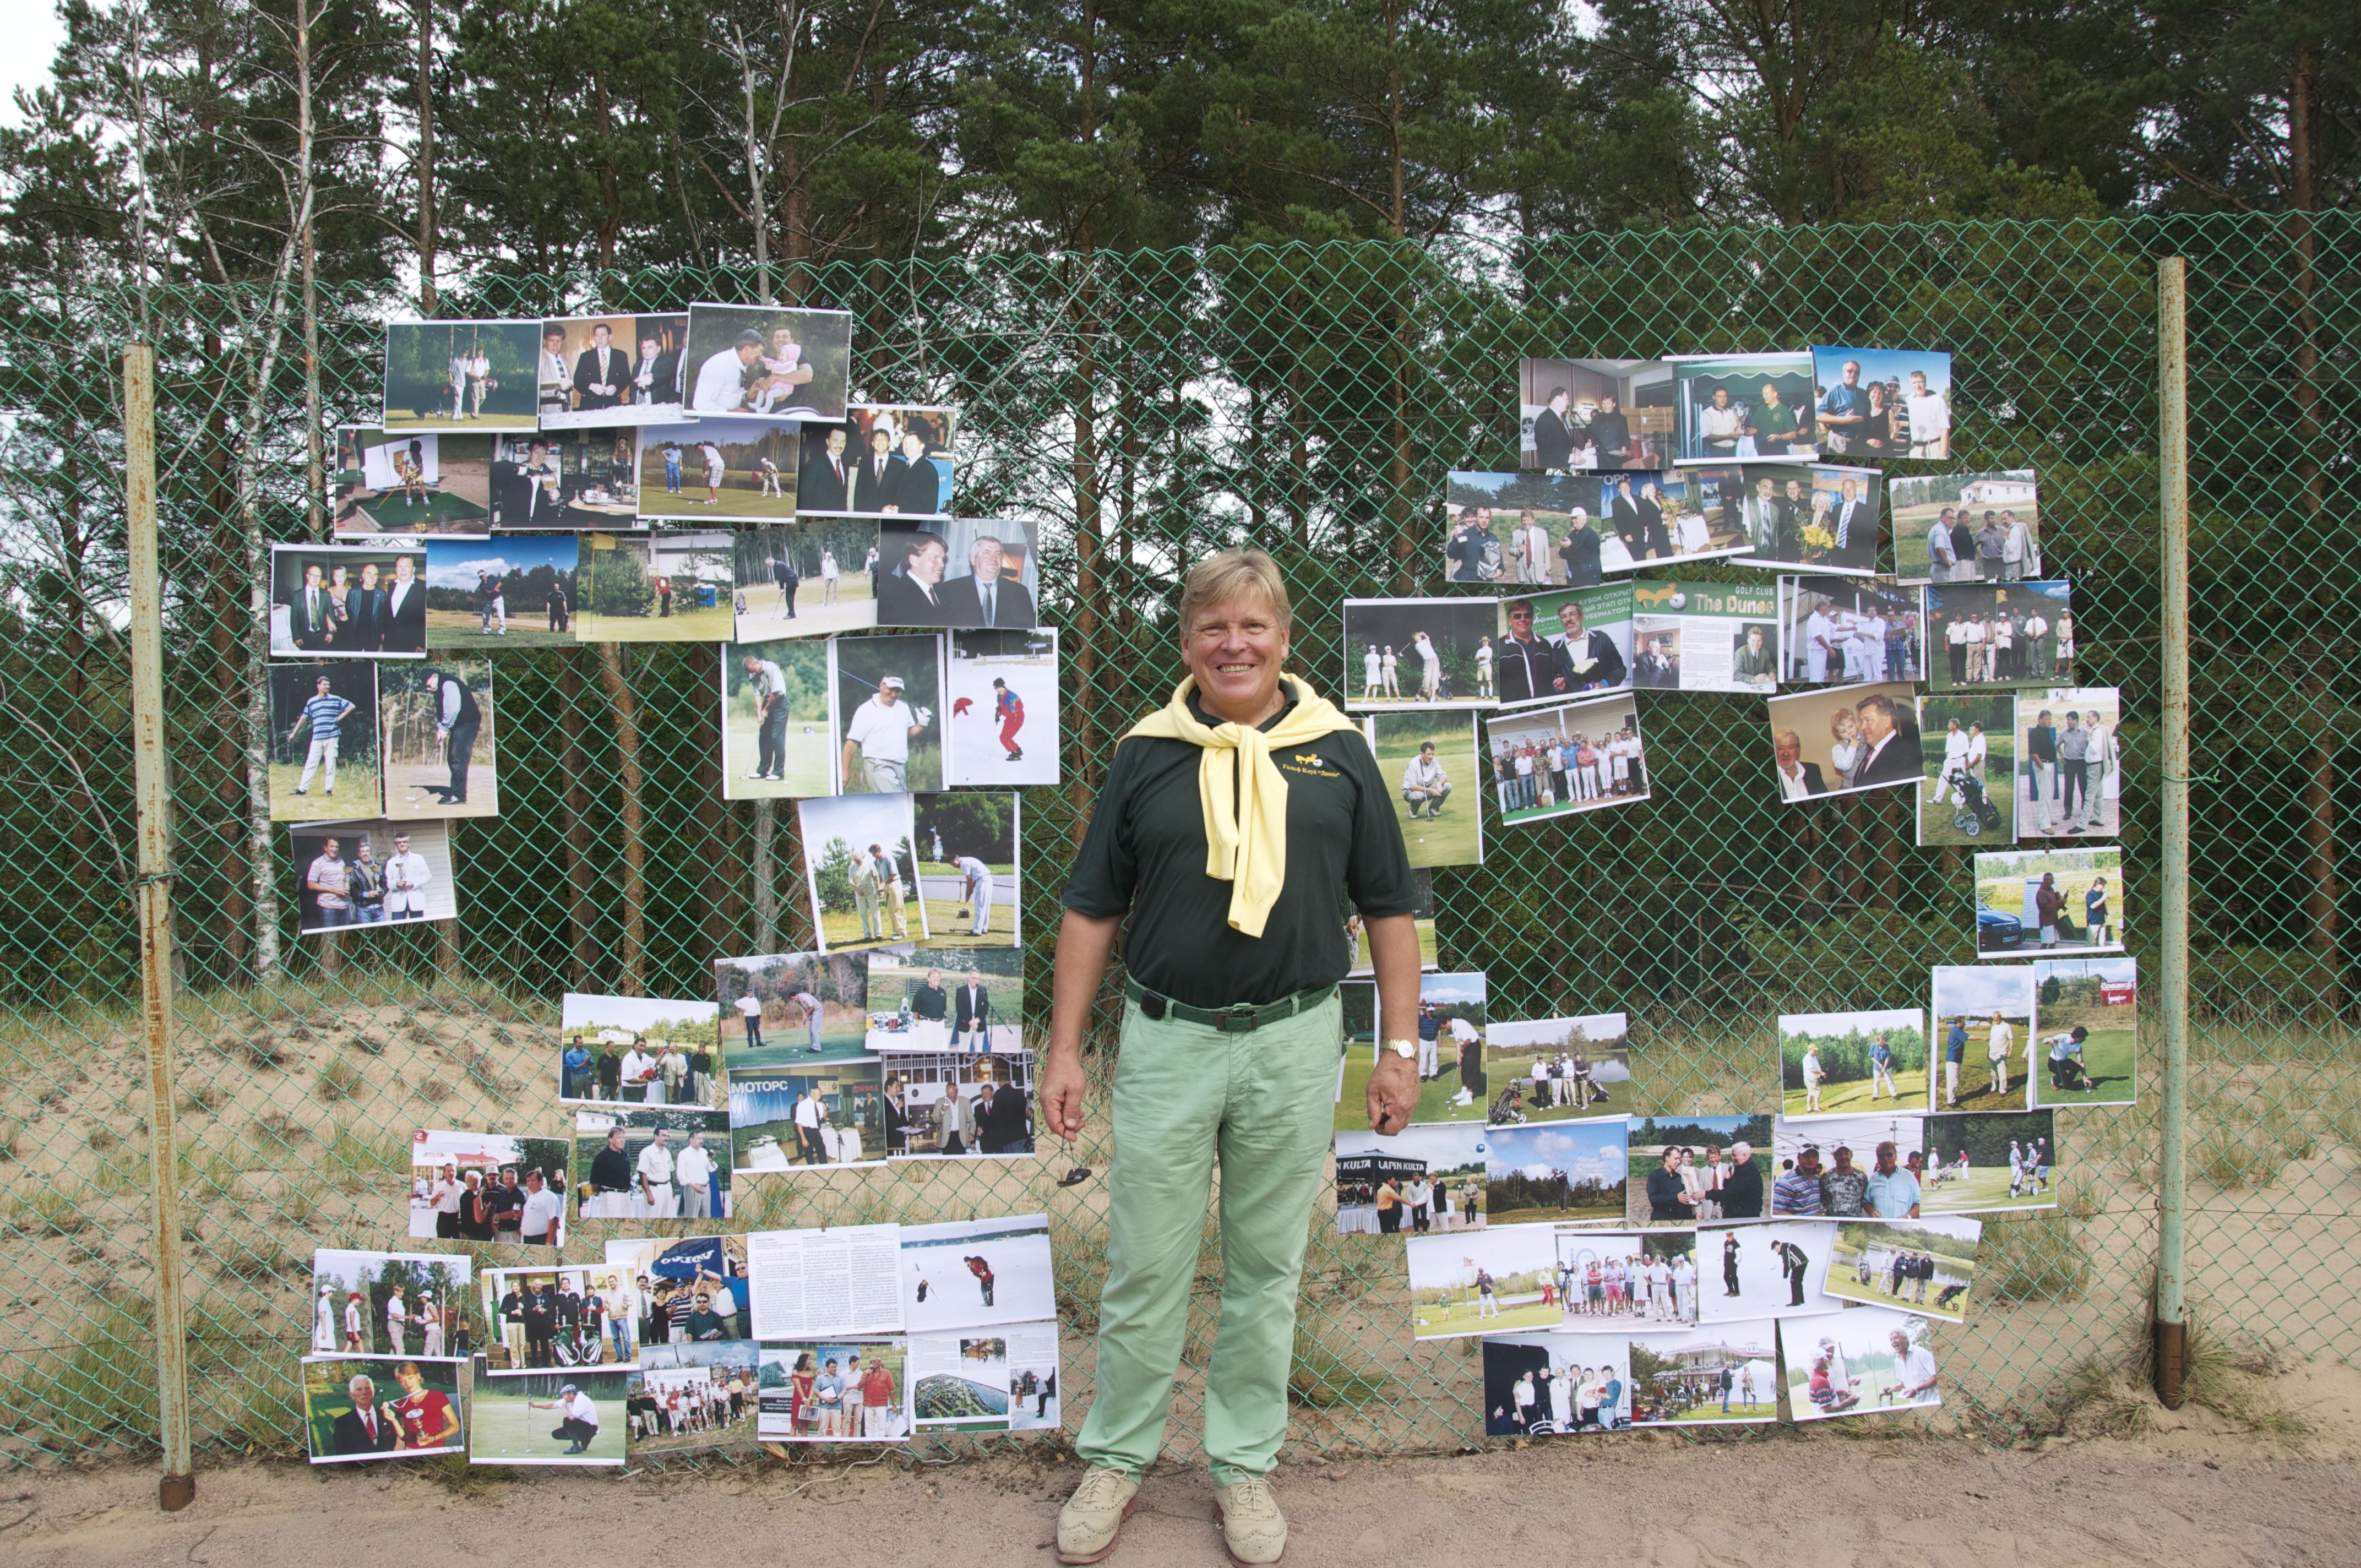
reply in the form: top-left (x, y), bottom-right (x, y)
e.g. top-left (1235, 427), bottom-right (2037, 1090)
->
top-left (2153, 255), bottom-right (2189, 1410)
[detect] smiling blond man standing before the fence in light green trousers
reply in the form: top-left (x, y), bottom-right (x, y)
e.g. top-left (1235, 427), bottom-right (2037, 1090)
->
top-left (1041, 550), bottom-right (1419, 1563)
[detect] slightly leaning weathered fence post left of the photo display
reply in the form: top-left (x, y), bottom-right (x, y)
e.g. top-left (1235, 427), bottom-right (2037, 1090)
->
top-left (123, 342), bottom-right (196, 1511)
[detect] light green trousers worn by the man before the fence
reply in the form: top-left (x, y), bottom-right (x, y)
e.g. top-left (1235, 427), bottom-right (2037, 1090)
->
top-left (1074, 997), bottom-right (1343, 1485)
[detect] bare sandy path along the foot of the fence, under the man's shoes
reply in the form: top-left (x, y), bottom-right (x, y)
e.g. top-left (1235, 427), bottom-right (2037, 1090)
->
top-left (0, 1431), bottom-right (2361, 1568)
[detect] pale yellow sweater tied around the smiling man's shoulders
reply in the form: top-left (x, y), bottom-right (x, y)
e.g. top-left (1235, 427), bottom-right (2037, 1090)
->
top-left (1124, 676), bottom-right (1360, 938)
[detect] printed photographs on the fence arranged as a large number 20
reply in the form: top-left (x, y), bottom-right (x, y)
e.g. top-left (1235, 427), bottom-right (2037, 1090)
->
top-left (285, 316), bottom-right (2137, 1467)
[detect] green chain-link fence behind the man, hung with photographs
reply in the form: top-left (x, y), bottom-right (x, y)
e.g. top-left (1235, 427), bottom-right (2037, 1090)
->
top-left (0, 217), bottom-right (2361, 1464)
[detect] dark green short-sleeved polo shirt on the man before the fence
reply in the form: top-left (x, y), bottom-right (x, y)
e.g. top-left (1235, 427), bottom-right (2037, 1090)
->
top-left (1065, 694), bottom-right (1417, 1008)
